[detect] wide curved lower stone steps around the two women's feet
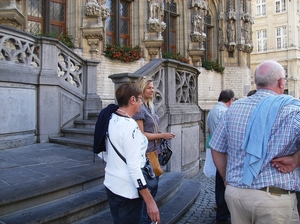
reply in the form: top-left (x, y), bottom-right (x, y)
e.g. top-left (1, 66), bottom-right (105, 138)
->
top-left (0, 167), bottom-right (200, 224)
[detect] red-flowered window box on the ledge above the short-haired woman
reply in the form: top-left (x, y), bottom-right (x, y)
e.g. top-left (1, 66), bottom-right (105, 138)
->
top-left (103, 44), bottom-right (142, 62)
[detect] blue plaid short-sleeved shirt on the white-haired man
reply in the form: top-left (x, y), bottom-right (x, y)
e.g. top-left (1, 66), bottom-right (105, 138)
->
top-left (209, 89), bottom-right (300, 191)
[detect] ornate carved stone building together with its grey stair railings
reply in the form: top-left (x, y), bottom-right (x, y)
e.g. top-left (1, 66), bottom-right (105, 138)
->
top-left (0, 0), bottom-right (253, 161)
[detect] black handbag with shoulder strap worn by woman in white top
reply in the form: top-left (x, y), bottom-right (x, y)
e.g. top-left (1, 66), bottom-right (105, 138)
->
top-left (107, 135), bottom-right (158, 193)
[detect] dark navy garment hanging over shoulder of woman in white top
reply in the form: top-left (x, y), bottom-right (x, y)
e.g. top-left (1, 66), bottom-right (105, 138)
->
top-left (93, 104), bottom-right (119, 161)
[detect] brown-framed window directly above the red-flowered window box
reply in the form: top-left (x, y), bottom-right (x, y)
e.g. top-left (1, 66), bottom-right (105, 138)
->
top-left (106, 0), bottom-right (132, 45)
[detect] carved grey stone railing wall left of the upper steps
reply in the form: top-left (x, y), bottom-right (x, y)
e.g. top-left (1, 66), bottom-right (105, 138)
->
top-left (0, 25), bottom-right (101, 148)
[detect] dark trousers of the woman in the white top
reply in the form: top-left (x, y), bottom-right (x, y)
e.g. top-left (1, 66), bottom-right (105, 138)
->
top-left (105, 188), bottom-right (143, 224)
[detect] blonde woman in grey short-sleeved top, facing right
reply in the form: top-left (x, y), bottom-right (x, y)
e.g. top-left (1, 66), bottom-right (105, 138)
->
top-left (133, 77), bottom-right (175, 224)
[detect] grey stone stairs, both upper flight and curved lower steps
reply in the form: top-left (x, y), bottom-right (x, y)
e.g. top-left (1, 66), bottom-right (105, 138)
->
top-left (8, 114), bottom-right (200, 224)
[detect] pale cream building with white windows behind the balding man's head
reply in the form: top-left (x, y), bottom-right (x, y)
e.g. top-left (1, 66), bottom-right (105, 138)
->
top-left (251, 0), bottom-right (300, 99)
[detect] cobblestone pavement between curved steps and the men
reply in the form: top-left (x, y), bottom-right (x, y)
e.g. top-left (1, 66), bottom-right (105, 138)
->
top-left (177, 153), bottom-right (216, 224)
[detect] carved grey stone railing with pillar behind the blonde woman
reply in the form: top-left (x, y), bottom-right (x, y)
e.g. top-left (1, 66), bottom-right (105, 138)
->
top-left (109, 59), bottom-right (201, 177)
